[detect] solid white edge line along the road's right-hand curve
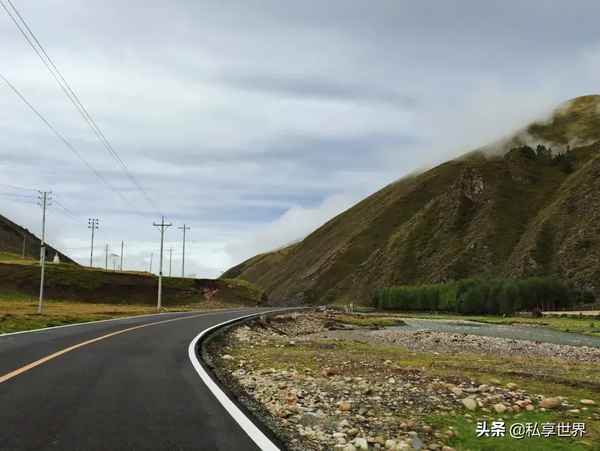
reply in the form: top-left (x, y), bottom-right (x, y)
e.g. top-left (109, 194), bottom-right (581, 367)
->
top-left (188, 309), bottom-right (304, 451)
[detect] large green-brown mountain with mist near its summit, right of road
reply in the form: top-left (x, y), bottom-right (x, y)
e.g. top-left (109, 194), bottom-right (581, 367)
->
top-left (223, 96), bottom-right (600, 303)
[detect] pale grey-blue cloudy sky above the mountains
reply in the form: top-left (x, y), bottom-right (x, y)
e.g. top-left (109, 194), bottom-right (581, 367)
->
top-left (0, 0), bottom-right (600, 277)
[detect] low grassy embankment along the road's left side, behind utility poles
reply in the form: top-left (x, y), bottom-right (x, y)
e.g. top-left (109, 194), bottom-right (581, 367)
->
top-left (0, 262), bottom-right (266, 333)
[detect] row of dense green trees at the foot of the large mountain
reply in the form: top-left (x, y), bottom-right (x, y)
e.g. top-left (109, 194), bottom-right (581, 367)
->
top-left (373, 277), bottom-right (593, 315)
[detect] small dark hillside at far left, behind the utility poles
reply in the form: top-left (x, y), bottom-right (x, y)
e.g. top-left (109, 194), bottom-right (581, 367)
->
top-left (0, 215), bottom-right (77, 264)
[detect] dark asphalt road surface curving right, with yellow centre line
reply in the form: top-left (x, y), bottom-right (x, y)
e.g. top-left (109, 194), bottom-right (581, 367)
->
top-left (0, 309), bottom-right (274, 451)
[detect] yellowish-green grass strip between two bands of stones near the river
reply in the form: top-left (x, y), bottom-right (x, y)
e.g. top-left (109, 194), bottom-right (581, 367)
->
top-left (229, 340), bottom-right (600, 390)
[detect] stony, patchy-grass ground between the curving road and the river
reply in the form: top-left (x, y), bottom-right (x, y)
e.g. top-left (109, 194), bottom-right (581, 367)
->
top-left (208, 312), bottom-right (600, 451)
